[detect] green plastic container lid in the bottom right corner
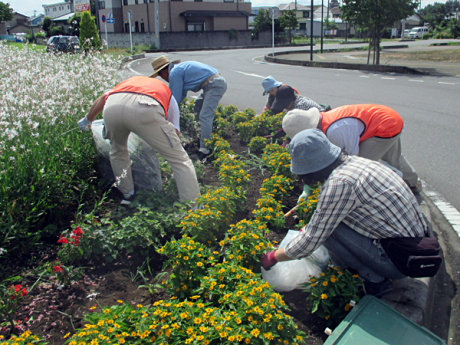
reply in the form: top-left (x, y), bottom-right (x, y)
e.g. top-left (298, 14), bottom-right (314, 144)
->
top-left (324, 295), bottom-right (445, 345)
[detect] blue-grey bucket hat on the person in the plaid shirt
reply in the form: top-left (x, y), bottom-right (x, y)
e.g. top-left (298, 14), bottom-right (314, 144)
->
top-left (289, 128), bottom-right (342, 175)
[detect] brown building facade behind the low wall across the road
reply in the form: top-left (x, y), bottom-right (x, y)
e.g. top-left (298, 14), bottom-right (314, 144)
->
top-left (98, 0), bottom-right (252, 33)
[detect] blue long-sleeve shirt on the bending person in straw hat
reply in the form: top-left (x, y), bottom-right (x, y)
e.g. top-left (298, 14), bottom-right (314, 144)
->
top-left (169, 61), bottom-right (219, 104)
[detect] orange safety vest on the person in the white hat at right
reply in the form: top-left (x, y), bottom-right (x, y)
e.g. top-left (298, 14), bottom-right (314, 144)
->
top-left (321, 104), bottom-right (404, 142)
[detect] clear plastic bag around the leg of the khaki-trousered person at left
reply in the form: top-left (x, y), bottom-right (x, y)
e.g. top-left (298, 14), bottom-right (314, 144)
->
top-left (91, 120), bottom-right (162, 191)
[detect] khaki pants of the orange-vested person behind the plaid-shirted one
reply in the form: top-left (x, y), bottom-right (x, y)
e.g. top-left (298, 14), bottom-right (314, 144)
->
top-left (359, 133), bottom-right (418, 187)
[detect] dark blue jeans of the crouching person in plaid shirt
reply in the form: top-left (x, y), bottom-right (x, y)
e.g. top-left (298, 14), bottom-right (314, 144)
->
top-left (323, 223), bottom-right (405, 283)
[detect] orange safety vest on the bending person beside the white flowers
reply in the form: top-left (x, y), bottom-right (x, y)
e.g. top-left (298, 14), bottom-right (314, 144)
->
top-left (105, 76), bottom-right (171, 118)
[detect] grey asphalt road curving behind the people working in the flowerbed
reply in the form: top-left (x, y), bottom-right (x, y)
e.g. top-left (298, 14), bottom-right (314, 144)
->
top-left (129, 41), bottom-right (460, 214)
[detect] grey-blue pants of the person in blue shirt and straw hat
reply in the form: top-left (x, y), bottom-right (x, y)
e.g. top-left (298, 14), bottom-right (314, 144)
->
top-left (194, 76), bottom-right (227, 148)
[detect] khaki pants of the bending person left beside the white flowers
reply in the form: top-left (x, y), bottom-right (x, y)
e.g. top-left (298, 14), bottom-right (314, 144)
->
top-left (103, 93), bottom-right (200, 201)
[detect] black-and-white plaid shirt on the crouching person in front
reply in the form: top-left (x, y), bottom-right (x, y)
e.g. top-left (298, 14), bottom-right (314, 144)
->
top-left (285, 156), bottom-right (428, 259)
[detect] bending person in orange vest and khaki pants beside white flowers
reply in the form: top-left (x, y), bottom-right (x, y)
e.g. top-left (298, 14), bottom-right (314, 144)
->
top-left (78, 76), bottom-right (200, 206)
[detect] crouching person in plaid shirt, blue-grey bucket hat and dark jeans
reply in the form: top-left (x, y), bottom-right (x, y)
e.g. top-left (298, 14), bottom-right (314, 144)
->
top-left (261, 128), bottom-right (431, 296)
